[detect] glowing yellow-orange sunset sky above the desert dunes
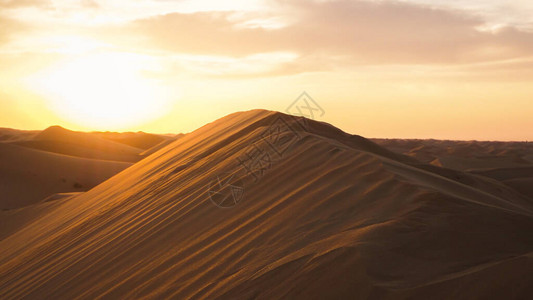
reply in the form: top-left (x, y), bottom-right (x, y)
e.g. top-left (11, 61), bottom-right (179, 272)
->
top-left (0, 0), bottom-right (533, 141)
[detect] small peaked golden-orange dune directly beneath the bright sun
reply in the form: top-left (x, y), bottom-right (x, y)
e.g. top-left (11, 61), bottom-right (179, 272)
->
top-left (16, 126), bottom-right (142, 162)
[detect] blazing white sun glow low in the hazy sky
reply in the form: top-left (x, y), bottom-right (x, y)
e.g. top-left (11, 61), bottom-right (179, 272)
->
top-left (30, 53), bottom-right (168, 129)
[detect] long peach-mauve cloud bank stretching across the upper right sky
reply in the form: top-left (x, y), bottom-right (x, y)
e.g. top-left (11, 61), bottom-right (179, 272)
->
top-left (122, 0), bottom-right (533, 64)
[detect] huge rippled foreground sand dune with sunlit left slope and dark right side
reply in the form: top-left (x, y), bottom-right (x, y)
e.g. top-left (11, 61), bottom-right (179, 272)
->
top-left (0, 110), bottom-right (533, 299)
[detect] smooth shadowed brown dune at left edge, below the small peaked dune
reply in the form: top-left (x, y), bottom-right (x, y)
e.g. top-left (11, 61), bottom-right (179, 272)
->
top-left (0, 143), bottom-right (131, 209)
